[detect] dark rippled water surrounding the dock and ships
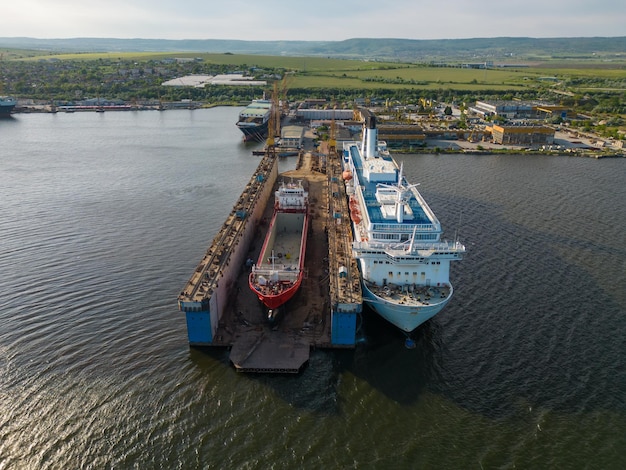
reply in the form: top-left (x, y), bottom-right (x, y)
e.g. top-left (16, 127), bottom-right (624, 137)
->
top-left (0, 108), bottom-right (626, 470)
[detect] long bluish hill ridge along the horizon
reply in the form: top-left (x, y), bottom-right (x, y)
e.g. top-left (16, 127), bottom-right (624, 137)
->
top-left (0, 36), bottom-right (626, 61)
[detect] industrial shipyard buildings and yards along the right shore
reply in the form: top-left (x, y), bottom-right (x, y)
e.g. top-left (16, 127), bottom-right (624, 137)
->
top-left (280, 99), bottom-right (624, 158)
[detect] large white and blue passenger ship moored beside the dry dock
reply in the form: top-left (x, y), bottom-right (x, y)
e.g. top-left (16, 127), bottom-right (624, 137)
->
top-left (343, 111), bottom-right (465, 334)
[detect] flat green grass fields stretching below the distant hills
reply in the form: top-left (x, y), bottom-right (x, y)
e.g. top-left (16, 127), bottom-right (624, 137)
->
top-left (14, 52), bottom-right (626, 92)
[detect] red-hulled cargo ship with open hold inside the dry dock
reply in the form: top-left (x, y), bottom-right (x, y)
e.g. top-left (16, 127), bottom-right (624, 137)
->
top-left (248, 181), bottom-right (309, 320)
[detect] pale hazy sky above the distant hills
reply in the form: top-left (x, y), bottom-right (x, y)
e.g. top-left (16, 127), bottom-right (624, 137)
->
top-left (0, 0), bottom-right (626, 41)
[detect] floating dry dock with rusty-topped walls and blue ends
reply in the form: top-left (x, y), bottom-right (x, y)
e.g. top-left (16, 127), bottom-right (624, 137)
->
top-left (178, 145), bottom-right (362, 373)
